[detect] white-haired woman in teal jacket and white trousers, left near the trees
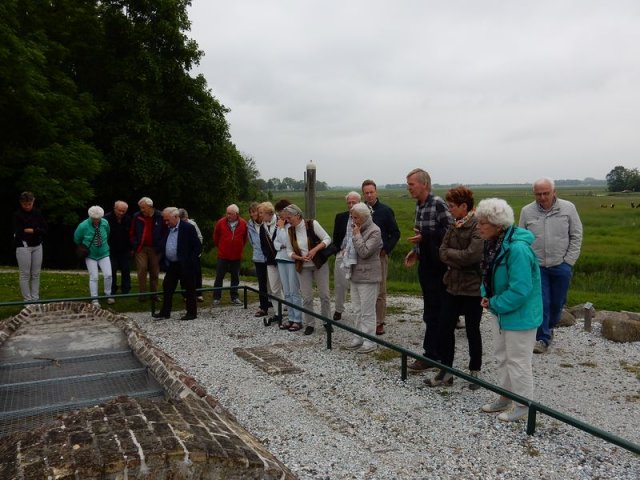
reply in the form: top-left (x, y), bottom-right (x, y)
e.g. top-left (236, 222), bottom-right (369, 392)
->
top-left (73, 206), bottom-right (114, 308)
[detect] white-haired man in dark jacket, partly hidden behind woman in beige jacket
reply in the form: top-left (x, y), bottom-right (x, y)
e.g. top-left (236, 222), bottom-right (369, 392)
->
top-left (333, 192), bottom-right (360, 320)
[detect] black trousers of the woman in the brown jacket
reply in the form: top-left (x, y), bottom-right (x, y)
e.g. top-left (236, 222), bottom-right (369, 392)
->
top-left (438, 292), bottom-right (482, 370)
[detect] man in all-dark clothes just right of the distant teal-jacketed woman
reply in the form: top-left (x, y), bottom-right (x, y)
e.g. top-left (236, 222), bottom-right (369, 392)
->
top-left (104, 200), bottom-right (131, 304)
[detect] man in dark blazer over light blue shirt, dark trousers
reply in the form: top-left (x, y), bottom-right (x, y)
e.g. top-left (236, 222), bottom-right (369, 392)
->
top-left (153, 207), bottom-right (202, 320)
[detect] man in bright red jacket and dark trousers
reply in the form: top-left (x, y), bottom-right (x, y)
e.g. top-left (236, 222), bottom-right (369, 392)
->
top-left (213, 204), bottom-right (249, 305)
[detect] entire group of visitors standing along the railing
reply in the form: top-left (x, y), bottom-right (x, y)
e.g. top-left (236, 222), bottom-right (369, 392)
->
top-left (14, 168), bottom-right (582, 421)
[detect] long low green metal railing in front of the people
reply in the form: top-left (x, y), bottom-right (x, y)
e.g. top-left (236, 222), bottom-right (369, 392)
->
top-left (0, 285), bottom-right (640, 455)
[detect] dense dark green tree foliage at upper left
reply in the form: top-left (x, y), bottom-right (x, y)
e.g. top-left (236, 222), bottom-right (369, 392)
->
top-left (0, 0), bottom-right (258, 259)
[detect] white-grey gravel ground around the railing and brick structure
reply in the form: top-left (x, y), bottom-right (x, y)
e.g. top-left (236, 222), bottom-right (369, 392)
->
top-left (130, 296), bottom-right (640, 480)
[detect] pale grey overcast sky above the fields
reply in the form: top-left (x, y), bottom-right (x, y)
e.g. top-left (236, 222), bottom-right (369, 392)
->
top-left (189, 0), bottom-right (640, 186)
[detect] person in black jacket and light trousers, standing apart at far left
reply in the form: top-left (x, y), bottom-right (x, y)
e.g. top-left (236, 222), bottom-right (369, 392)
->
top-left (13, 192), bottom-right (47, 302)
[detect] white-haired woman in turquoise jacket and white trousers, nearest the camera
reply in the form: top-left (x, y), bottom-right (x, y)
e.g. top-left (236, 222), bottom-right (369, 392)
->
top-left (476, 198), bottom-right (542, 422)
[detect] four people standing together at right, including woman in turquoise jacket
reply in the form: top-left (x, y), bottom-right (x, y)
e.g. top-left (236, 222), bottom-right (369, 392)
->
top-left (405, 169), bottom-right (582, 421)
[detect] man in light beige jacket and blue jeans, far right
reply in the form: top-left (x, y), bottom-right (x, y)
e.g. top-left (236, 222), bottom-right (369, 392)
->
top-left (519, 178), bottom-right (582, 353)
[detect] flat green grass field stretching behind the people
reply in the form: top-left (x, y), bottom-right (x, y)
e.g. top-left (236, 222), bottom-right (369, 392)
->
top-left (0, 187), bottom-right (640, 314)
